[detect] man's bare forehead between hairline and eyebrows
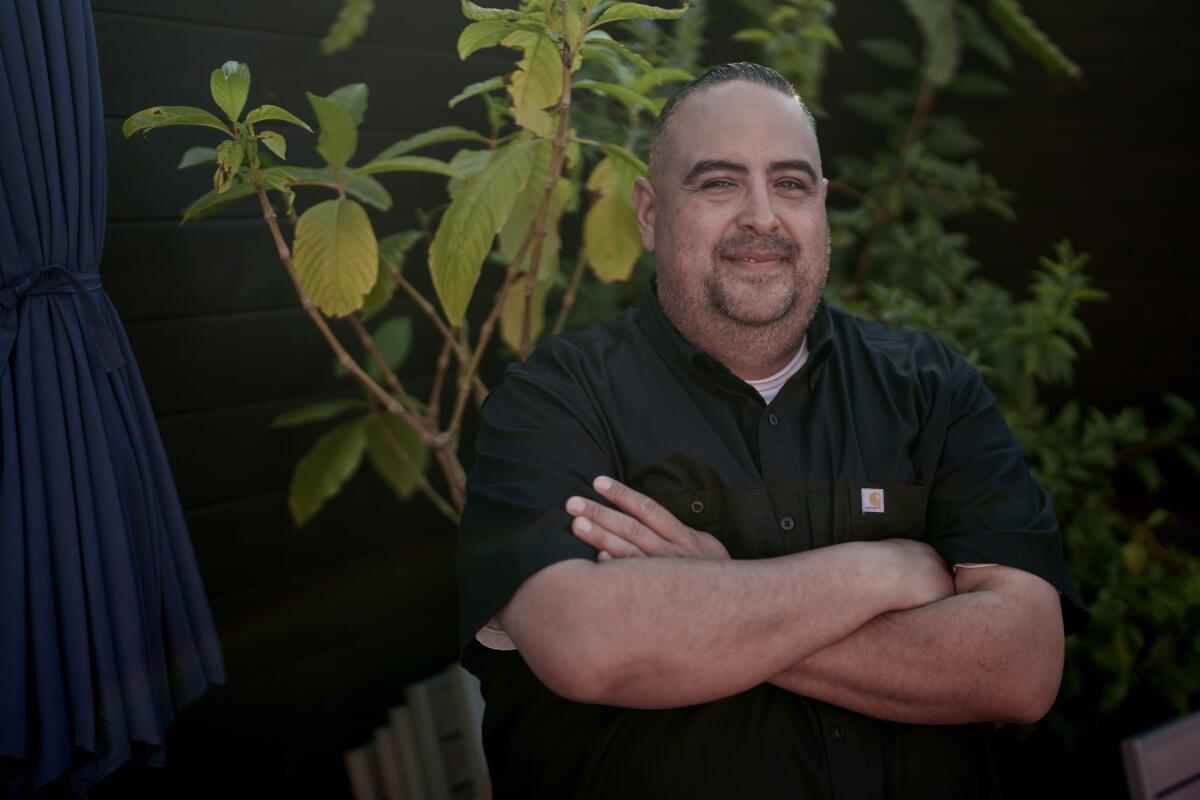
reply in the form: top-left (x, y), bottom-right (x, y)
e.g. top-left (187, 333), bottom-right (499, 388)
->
top-left (665, 80), bottom-right (821, 173)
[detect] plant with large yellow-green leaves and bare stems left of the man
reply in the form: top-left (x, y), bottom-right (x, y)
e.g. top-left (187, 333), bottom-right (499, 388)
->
top-left (122, 0), bottom-right (691, 524)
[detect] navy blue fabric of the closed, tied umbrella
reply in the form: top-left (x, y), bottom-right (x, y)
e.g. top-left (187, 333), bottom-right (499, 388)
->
top-left (0, 0), bottom-right (224, 798)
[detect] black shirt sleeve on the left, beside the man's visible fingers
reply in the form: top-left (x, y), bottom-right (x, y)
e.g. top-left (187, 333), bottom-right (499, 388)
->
top-left (457, 359), bottom-right (620, 648)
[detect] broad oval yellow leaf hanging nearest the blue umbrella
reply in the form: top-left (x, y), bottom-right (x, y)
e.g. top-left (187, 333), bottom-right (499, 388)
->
top-left (293, 198), bottom-right (379, 317)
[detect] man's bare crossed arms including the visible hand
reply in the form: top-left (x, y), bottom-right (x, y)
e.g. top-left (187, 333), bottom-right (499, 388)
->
top-left (499, 479), bottom-right (1063, 724)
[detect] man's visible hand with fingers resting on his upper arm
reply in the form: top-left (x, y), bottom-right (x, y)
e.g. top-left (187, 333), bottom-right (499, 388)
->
top-left (566, 476), bottom-right (730, 561)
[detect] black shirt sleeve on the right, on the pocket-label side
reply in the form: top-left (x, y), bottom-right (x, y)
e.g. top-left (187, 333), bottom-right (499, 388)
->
top-left (926, 363), bottom-right (1087, 633)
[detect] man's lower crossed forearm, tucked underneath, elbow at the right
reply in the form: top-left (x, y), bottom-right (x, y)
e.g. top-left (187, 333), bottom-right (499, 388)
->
top-left (770, 573), bottom-right (1063, 724)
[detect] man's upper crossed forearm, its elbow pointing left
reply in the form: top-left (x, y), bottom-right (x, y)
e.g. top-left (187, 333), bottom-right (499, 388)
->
top-left (500, 543), bottom-right (921, 708)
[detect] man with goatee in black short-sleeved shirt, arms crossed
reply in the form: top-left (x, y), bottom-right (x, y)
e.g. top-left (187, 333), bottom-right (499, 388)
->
top-left (460, 64), bottom-right (1081, 798)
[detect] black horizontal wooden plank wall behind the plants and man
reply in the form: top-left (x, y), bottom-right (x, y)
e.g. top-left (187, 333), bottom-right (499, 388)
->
top-left (94, 0), bottom-right (1200, 798)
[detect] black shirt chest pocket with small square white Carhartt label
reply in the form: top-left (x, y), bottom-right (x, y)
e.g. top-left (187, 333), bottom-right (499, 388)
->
top-left (808, 483), bottom-right (929, 545)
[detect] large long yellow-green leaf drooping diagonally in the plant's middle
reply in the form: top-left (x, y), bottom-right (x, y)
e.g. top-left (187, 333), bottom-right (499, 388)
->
top-left (430, 140), bottom-right (550, 325)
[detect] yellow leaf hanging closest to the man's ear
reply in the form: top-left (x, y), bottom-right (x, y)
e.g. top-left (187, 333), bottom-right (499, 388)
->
top-left (583, 158), bottom-right (642, 283)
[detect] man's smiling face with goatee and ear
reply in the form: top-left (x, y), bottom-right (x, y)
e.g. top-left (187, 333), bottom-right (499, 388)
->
top-left (635, 80), bottom-right (829, 371)
